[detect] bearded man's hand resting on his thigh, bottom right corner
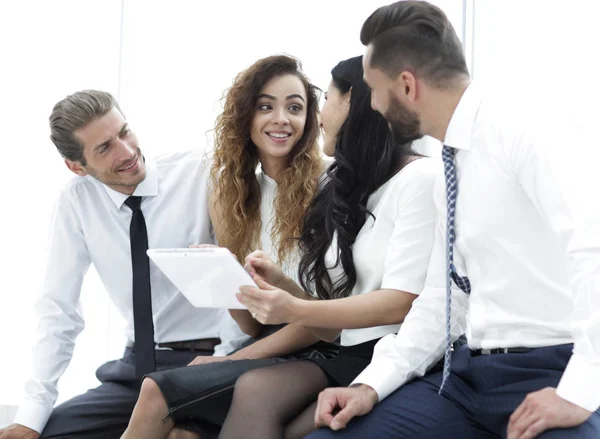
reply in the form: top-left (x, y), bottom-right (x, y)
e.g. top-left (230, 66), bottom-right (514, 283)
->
top-left (507, 387), bottom-right (592, 439)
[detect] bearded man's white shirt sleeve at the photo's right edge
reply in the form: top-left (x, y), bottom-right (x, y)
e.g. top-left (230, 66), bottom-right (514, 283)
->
top-left (510, 120), bottom-right (600, 411)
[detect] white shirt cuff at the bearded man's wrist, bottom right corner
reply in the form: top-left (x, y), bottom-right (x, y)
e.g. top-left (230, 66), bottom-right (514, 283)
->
top-left (556, 353), bottom-right (600, 412)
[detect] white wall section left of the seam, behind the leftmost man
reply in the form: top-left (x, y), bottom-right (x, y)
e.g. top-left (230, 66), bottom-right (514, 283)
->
top-left (0, 0), bottom-right (121, 404)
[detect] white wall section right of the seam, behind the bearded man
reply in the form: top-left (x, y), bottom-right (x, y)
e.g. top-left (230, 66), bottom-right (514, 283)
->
top-left (472, 0), bottom-right (600, 130)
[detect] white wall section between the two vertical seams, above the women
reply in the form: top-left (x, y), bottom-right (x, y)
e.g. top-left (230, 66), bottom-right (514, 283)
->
top-left (121, 0), bottom-right (463, 158)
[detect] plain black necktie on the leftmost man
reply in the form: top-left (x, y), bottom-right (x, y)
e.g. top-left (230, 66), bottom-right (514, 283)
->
top-left (125, 196), bottom-right (156, 378)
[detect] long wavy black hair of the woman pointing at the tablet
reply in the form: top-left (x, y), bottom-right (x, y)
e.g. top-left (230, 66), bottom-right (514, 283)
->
top-left (298, 56), bottom-right (414, 299)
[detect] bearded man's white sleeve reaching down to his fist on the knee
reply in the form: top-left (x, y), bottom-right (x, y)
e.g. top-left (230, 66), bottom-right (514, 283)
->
top-left (353, 201), bottom-right (469, 401)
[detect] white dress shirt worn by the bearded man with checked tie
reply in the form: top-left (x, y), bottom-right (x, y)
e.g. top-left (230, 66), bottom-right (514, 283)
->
top-left (355, 83), bottom-right (600, 411)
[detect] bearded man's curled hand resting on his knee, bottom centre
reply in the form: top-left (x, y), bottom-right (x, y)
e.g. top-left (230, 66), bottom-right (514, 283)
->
top-left (315, 384), bottom-right (378, 430)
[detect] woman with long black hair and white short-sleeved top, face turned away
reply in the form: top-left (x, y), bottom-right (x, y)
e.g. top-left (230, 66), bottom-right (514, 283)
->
top-left (219, 57), bottom-right (441, 439)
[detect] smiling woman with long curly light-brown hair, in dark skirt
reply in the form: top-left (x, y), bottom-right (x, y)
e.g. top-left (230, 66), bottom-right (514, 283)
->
top-left (123, 55), bottom-right (337, 438)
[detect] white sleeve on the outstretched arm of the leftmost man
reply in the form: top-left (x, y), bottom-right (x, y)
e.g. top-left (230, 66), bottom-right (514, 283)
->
top-left (14, 189), bottom-right (91, 432)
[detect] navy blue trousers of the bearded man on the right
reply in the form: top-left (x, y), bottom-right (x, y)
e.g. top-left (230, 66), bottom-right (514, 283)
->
top-left (307, 344), bottom-right (600, 439)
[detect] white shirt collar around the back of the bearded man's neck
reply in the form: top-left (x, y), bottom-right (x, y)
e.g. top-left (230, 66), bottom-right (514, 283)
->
top-left (444, 82), bottom-right (482, 150)
